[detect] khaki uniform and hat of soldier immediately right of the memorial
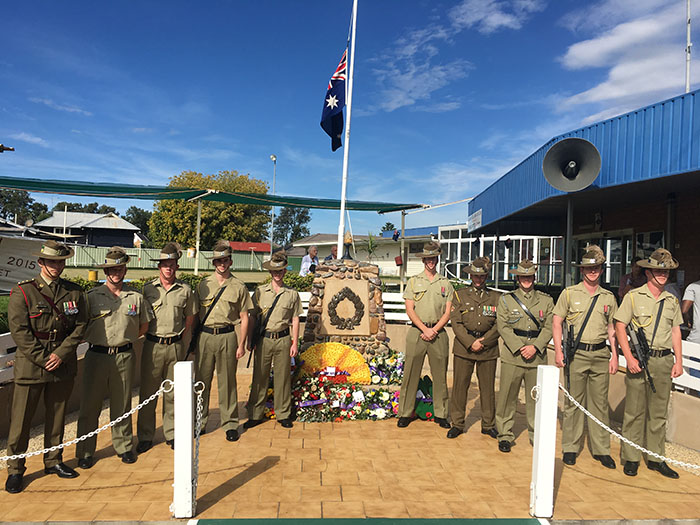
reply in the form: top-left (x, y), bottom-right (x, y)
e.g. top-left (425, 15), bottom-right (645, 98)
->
top-left (398, 243), bottom-right (454, 419)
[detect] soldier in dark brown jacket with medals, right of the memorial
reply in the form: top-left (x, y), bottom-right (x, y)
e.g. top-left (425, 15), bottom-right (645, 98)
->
top-left (447, 257), bottom-right (501, 438)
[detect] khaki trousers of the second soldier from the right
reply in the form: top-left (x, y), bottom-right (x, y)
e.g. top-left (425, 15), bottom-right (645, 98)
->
top-left (561, 348), bottom-right (610, 456)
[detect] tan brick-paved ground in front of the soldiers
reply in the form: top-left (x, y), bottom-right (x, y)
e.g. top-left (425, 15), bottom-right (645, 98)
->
top-left (0, 374), bottom-right (700, 521)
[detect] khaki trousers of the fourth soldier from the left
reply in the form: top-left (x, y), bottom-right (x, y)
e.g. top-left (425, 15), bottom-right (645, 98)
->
top-left (196, 331), bottom-right (238, 430)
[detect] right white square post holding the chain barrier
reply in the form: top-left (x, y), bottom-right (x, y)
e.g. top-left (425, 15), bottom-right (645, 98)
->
top-left (525, 365), bottom-right (559, 518)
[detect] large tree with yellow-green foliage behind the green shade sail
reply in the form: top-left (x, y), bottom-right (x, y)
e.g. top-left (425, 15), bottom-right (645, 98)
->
top-left (148, 171), bottom-right (270, 249)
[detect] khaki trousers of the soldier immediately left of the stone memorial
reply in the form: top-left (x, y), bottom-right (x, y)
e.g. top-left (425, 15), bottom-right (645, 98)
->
top-left (249, 336), bottom-right (292, 420)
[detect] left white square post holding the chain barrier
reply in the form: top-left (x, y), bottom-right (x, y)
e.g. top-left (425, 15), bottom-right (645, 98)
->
top-left (171, 361), bottom-right (197, 518)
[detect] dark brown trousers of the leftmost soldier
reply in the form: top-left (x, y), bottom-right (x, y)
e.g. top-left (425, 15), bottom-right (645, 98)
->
top-left (7, 379), bottom-right (73, 474)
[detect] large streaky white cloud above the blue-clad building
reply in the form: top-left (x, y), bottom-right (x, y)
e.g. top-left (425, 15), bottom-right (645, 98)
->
top-left (556, 0), bottom-right (700, 118)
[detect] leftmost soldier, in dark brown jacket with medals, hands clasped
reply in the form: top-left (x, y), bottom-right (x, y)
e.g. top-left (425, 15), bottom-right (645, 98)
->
top-left (5, 241), bottom-right (88, 494)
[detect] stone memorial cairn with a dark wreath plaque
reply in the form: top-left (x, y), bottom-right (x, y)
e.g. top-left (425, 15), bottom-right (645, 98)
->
top-left (302, 259), bottom-right (390, 358)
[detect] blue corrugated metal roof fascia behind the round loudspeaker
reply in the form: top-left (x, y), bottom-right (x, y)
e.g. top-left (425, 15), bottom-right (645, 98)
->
top-left (469, 90), bottom-right (700, 226)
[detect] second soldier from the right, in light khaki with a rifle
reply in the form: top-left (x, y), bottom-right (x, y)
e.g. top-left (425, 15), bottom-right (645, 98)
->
top-left (552, 245), bottom-right (617, 469)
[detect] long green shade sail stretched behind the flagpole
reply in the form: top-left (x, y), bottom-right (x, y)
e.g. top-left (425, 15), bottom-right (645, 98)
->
top-left (0, 176), bottom-right (422, 213)
